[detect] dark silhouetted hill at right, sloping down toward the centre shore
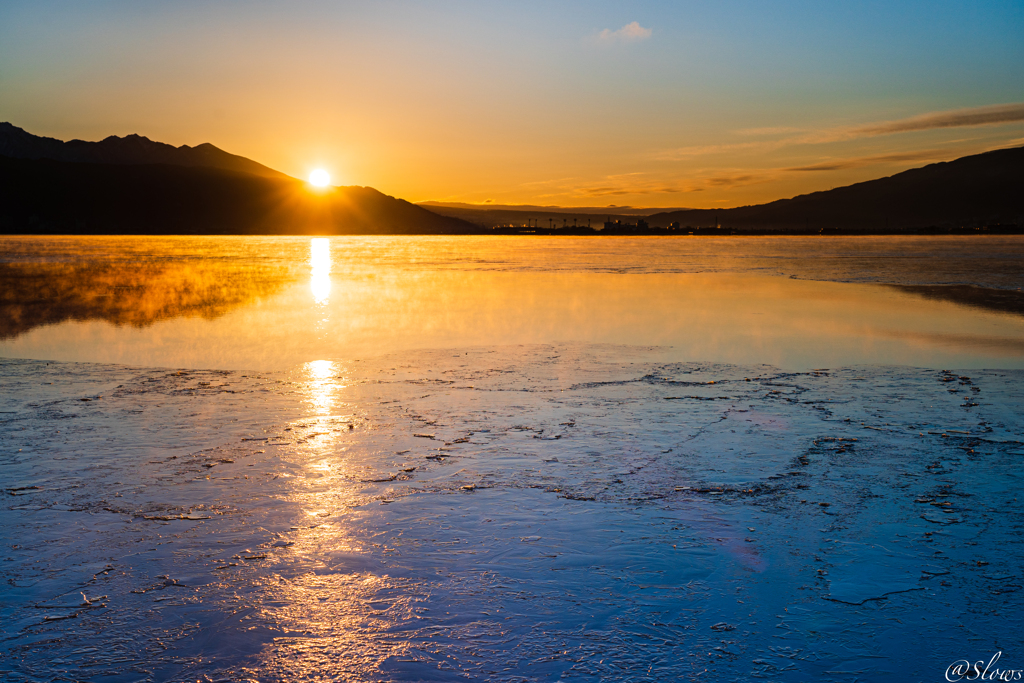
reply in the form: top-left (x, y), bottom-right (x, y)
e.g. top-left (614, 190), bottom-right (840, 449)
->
top-left (647, 147), bottom-right (1024, 231)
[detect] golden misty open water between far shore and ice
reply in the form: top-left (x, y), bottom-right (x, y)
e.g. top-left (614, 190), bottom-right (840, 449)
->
top-left (0, 237), bottom-right (1024, 370)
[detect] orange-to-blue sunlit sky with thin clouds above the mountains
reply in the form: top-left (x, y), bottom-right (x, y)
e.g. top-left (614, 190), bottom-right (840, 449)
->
top-left (0, 0), bottom-right (1024, 208)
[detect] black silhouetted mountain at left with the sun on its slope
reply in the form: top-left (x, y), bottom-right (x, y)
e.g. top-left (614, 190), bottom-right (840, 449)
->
top-left (0, 124), bottom-right (478, 234)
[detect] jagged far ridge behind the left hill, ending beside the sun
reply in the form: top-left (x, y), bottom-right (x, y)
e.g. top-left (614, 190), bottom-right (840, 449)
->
top-left (0, 123), bottom-right (290, 178)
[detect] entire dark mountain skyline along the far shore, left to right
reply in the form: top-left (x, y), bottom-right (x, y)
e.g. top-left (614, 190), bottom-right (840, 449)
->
top-left (0, 124), bottom-right (1024, 234)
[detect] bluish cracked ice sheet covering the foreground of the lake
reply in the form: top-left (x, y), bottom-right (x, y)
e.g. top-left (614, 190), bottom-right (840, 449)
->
top-left (0, 345), bottom-right (1024, 681)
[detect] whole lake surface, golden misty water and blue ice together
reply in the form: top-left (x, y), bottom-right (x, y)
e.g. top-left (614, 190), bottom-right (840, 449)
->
top-left (0, 239), bottom-right (1024, 681)
